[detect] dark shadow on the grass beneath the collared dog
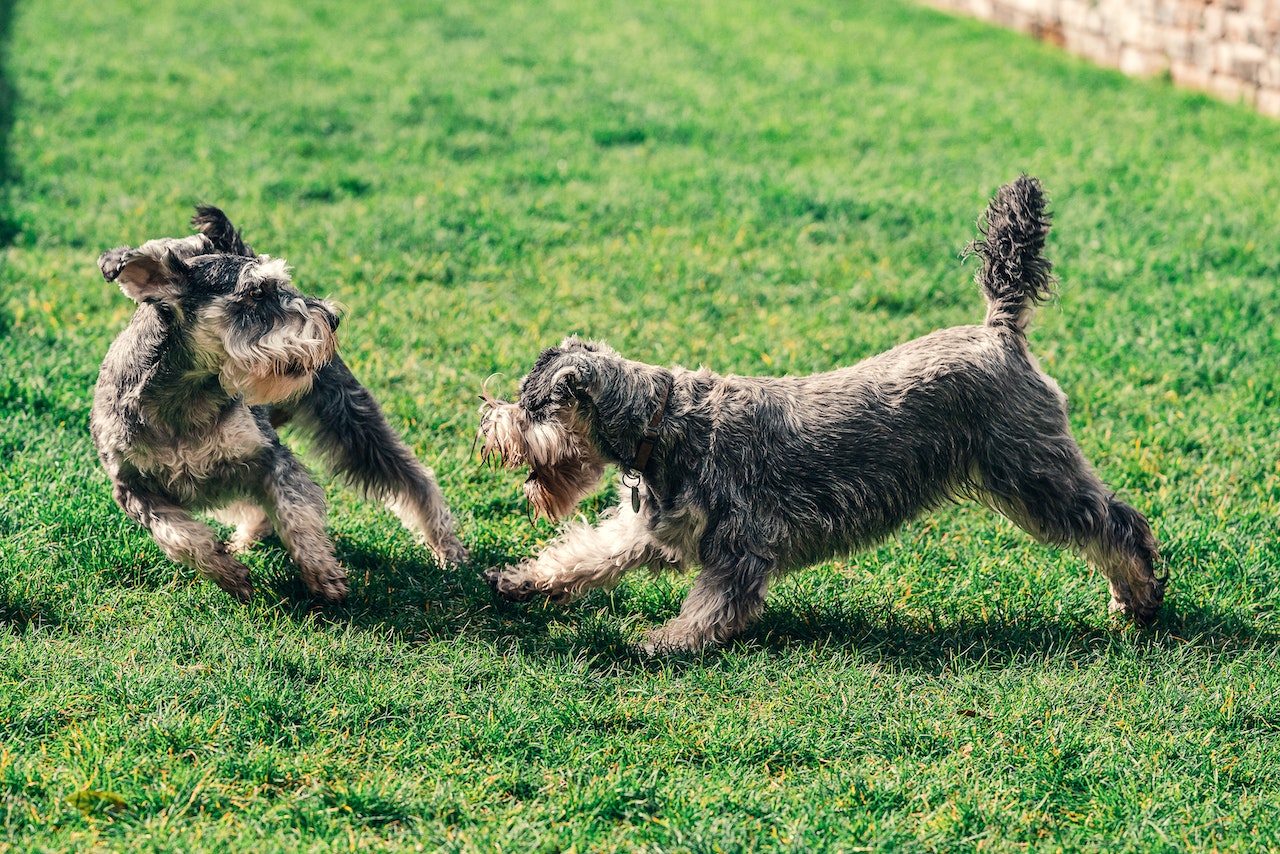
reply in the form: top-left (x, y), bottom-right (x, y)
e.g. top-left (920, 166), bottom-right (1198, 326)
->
top-left (276, 543), bottom-right (1280, 673)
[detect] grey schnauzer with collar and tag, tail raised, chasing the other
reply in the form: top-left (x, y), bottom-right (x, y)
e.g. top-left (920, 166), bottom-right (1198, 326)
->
top-left (480, 175), bottom-right (1166, 650)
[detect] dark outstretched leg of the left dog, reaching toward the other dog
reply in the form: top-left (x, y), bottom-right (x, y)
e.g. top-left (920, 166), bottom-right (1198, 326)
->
top-left (273, 357), bottom-right (467, 565)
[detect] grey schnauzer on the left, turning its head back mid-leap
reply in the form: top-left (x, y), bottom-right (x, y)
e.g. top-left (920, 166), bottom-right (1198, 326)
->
top-left (90, 206), bottom-right (466, 602)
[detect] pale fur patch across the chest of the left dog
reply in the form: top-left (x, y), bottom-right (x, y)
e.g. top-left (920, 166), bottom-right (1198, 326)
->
top-left (123, 407), bottom-right (271, 487)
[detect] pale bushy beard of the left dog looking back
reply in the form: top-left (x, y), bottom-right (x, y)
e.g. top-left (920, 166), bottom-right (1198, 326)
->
top-left (206, 303), bottom-right (338, 406)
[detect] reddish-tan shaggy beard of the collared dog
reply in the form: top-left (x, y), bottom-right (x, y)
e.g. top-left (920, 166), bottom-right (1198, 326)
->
top-left (480, 396), bottom-right (605, 520)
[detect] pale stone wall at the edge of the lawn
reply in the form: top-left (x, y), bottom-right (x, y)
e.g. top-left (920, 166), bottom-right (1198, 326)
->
top-left (924, 0), bottom-right (1280, 117)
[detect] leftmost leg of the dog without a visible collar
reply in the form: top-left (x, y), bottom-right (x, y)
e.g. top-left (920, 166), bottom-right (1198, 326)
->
top-left (115, 484), bottom-right (253, 602)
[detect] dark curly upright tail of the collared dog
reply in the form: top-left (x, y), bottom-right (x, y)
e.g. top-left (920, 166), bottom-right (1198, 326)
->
top-left (965, 175), bottom-right (1056, 333)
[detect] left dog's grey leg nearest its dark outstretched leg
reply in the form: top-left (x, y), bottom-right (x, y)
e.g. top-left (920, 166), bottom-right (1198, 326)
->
top-left (264, 447), bottom-right (347, 602)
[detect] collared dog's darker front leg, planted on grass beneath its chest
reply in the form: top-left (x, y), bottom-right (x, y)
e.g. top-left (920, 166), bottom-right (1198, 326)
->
top-left (644, 552), bottom-right (773, 653)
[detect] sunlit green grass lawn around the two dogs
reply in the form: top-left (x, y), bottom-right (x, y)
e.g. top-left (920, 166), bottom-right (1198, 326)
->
top-left (0, 0), bottom-right (1280, 853)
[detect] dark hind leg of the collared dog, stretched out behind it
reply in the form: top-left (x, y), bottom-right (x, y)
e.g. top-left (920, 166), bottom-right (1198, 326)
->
top-left (982, 435), bottom-right (1167, 625)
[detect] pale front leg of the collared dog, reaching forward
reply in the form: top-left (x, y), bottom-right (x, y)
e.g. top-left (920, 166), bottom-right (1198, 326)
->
top-left (485, 508), bottom-right (663, 602)
